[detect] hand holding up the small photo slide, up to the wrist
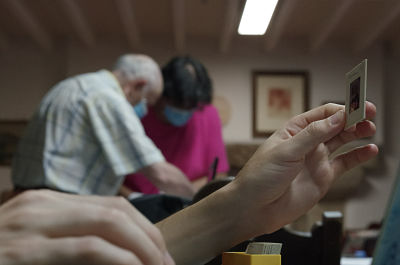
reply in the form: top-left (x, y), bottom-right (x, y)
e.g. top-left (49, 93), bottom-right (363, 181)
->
top-left (232, 102), bottom-right (378, 233)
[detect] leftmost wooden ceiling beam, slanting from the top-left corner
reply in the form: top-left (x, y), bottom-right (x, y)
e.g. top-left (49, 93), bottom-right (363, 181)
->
top-left (3, 0), bottom-right (53, 51)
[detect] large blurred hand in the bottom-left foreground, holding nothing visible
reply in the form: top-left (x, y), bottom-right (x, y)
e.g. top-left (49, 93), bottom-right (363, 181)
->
top-left (0, 190), bottom-right (174, 265)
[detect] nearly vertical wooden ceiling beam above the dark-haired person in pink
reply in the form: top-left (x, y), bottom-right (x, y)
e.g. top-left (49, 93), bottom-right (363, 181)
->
top-left (172, 0), bottom-right (186, 52)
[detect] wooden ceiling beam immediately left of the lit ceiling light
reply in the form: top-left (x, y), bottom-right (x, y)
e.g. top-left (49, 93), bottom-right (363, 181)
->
top-left (219, 0), bottom-right (240, 53)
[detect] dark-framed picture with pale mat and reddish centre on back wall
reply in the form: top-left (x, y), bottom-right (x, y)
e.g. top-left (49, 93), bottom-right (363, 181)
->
top-left (253, 71), bottom-right (308, 137)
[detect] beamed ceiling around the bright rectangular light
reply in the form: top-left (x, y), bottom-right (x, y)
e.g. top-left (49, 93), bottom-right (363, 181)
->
top-left (0, 0), bottom-right (400, 52)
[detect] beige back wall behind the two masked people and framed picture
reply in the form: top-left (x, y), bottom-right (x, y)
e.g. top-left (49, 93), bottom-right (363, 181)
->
top-left (0, 40), bottom-right (400, 227)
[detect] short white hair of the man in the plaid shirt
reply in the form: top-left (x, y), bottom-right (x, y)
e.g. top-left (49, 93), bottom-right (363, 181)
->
top-left (113, 54), bottom-right (161, 90)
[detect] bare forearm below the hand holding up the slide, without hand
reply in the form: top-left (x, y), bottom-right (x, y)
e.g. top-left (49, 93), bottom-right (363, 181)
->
top-left (157, 180), bottom-right (254, 265)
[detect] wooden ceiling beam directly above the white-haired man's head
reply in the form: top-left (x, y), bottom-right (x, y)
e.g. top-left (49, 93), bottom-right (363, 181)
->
top-left (114, 0), bottom-right (141, 49)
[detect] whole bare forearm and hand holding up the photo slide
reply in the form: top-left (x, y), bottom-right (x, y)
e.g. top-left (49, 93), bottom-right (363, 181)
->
top-left (157, 102), bottom-right (378, 265)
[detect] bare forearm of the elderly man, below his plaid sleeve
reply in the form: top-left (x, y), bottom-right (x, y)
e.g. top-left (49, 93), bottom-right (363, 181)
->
top-left (139, 162), bottom-right (195, 198)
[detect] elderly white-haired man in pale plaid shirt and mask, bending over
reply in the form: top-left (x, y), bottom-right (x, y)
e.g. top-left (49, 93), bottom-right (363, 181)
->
top-left (12, 54), bottom-right (194, 197)
